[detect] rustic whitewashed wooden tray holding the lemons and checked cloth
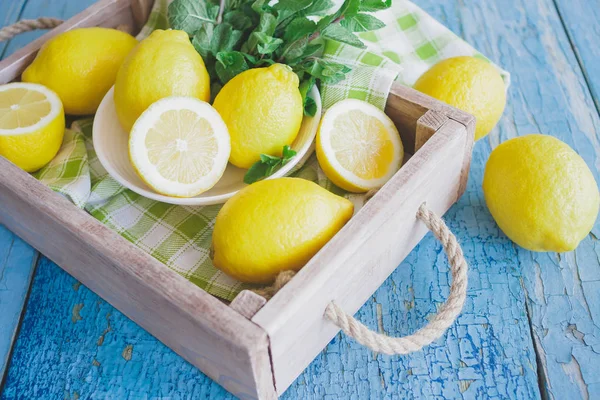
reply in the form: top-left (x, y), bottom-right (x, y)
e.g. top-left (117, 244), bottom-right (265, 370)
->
top-left (0, 0), bottom-right (475, 399)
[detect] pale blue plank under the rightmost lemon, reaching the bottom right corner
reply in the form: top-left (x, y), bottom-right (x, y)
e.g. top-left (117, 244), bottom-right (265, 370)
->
top-left (424, 0), bottom-right (600, 399)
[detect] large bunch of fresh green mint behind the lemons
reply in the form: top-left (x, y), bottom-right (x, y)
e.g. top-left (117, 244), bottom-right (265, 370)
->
top-left (168, 0), bottom-right (391, 102)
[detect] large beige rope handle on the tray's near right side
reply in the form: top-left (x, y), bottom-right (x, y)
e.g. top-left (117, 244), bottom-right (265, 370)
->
top-left (325, 203), bottom-right (468, 355)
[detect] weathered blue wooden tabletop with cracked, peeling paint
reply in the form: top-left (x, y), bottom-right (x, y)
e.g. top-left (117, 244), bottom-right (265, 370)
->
top-left (0, 0), bottom-right (600, 399)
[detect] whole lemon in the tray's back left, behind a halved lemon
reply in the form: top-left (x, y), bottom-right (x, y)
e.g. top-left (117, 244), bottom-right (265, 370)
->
top-left (22, 28), bottom-right (137, 115)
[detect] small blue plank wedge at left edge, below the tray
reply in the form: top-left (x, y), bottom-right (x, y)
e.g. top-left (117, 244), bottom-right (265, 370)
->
top-left (0, 225), bottom-right (38, 386)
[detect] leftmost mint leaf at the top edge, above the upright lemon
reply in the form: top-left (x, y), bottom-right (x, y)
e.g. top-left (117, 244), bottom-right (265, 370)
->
top-left (168, 0), bottom-right (219, 36)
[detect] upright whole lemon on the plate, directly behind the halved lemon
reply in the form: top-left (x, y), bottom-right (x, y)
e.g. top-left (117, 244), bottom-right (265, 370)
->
top-left (115, 29), bottom-right (210, 132)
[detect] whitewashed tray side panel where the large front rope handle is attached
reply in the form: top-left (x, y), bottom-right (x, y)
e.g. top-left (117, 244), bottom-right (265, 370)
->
top-left (253, 120), bottom-right (471, 394)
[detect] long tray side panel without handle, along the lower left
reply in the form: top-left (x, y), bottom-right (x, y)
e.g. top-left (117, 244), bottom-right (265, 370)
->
top-left (0, 157), bottom-right (275, 398)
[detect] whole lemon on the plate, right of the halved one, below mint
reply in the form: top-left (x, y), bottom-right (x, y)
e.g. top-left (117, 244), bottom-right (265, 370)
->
top-left (214, 64), bottom-right (303, 168)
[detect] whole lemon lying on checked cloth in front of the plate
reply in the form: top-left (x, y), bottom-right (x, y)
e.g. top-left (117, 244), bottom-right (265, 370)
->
top-left (212, 178), bottom-right (354, 283)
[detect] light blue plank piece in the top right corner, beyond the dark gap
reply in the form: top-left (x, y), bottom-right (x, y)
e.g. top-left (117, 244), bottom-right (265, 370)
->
top-left (554, 0), bottom-right (600, 111)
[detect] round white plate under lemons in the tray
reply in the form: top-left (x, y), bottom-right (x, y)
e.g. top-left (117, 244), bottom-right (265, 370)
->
top-left (93, 87), bottom-right (321, 206)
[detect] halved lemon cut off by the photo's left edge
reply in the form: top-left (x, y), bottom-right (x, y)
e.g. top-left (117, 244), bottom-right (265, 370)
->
top-left (0, 82), bottom-right (65, 172)
